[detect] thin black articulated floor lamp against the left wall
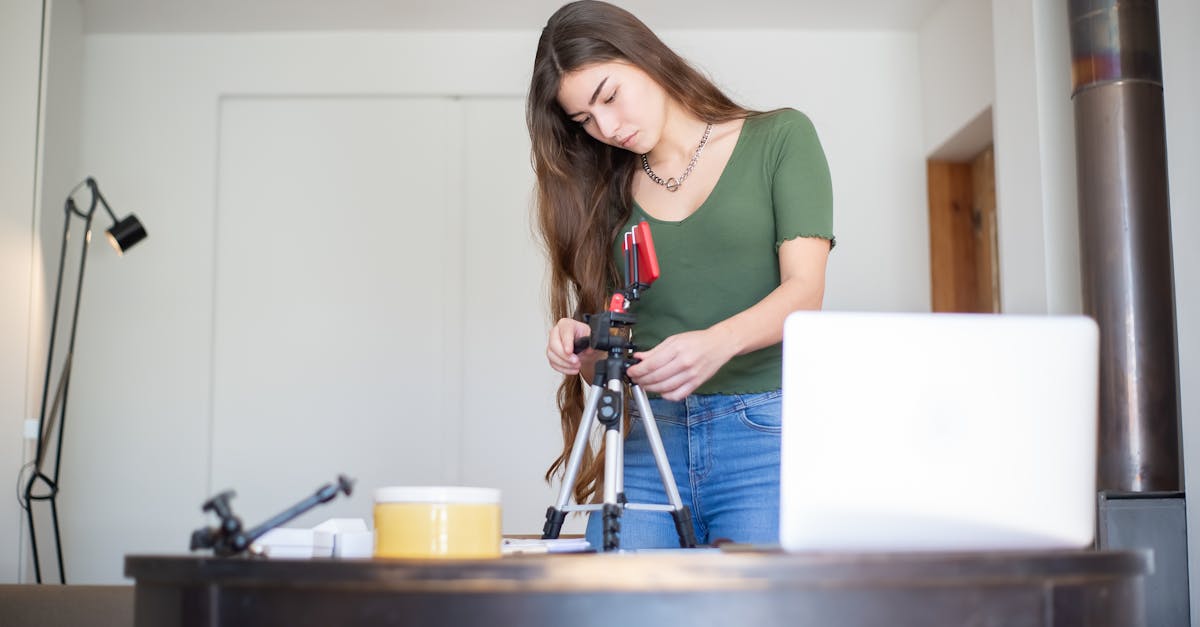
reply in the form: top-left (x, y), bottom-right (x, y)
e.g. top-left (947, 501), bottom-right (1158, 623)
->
top-left (22, 177), bottom-right (146, 584)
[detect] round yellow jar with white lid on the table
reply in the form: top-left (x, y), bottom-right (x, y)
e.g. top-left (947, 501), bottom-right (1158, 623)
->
top-left (374, 486), bottom-right (500, 559)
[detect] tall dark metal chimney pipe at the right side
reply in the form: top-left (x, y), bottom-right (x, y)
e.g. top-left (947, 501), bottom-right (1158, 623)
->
top-left (1069, 0), bottom-right (1183, 492)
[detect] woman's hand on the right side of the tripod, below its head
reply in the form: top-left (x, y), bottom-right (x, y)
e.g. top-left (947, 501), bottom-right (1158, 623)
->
top-left (626, 327), bottom-right (737, 401)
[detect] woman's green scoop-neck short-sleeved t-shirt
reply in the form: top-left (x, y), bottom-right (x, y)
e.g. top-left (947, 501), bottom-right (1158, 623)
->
top-left (613, 109), bottom-right (833, 394)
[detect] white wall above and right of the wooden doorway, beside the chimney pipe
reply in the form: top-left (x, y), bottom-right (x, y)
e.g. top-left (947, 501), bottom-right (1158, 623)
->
top-left (919, 0), bottom-right (1082, 314)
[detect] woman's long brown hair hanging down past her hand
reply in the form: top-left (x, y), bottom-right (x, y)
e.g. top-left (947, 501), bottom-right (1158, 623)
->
top-left (526, 0), bottom-right (751, 503)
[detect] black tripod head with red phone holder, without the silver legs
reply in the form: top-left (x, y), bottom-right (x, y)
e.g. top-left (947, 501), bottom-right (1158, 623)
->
top-left (575, 220), bottom-right (660, 356)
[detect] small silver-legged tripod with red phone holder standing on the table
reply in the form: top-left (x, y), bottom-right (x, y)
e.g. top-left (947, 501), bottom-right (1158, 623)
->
top-left (541, 221), bottom-right (696, 551)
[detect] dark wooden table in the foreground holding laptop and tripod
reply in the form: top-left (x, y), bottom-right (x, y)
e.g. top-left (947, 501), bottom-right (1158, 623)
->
top-left (125, 550), bottom-right (1152, 627)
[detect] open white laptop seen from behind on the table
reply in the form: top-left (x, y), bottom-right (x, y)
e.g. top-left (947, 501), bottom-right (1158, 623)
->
top-left (780, 312), bottom-right (1099, 551)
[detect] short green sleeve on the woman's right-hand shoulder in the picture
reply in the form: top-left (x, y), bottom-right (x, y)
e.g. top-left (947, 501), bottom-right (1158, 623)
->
top-left (772, 109), bottom-right (834, 249)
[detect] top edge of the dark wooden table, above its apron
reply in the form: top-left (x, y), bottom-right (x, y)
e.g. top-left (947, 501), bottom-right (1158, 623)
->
top-left (125, 550), bottom-right (1153, 592)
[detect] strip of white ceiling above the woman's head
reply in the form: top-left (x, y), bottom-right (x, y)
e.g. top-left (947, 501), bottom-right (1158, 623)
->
top-left (80, 0), bottom-right (943, 32)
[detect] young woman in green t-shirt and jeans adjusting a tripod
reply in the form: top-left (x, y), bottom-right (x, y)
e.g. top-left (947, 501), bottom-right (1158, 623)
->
top-left (527, 0), bottom-right (834, 549)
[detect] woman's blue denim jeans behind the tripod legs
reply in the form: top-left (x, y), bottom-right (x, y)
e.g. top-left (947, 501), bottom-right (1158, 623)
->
top-left (587, 390), bottom-right (782, 549)
